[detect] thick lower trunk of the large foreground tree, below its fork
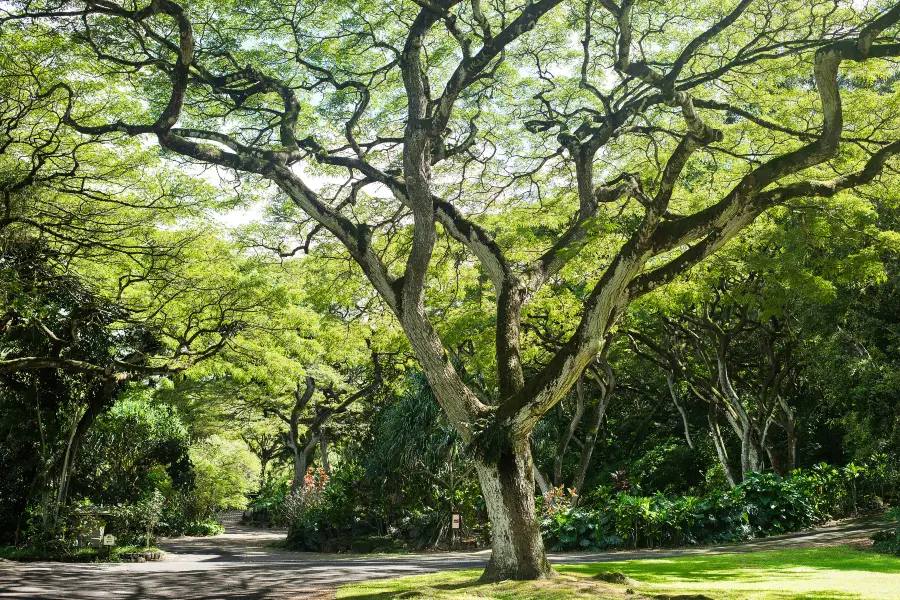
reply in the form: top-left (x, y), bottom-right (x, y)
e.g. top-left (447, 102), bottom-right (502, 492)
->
top-left (475, 440), bottom-right (553, 581)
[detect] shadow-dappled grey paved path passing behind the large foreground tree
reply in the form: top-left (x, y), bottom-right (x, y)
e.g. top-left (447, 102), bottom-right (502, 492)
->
top-left (0, 519), bottom-right (885, 600)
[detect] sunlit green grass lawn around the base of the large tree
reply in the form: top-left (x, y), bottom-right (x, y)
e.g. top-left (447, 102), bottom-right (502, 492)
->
top-left (337, 547), bottom-right (900, 600)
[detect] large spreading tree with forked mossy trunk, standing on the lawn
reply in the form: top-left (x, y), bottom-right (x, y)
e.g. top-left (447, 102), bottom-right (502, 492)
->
top-left (2, 0), bottom-right (900, 579)
